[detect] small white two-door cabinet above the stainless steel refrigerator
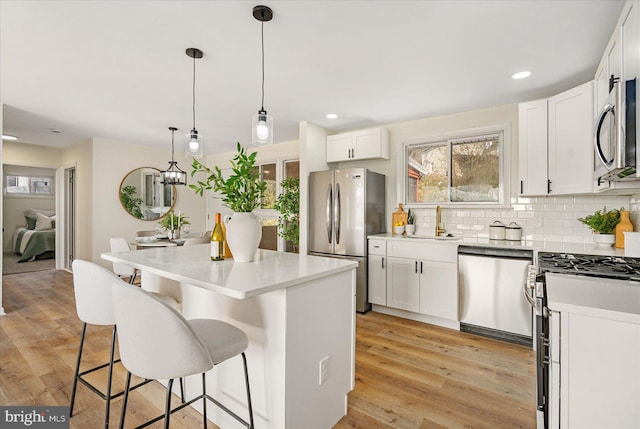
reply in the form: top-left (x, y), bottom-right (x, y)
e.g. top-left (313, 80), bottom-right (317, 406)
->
top-left (327, 128), bottom-right (389, 162)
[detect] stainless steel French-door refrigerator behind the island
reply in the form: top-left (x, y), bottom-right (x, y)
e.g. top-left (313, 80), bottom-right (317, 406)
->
top-left (308, 168), bottom-right (386, 313)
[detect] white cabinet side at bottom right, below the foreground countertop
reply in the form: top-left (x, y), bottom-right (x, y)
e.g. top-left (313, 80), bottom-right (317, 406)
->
top-left (551, 311), bottom-right (640, 429)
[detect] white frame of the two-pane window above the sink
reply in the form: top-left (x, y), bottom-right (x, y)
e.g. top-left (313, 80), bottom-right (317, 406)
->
top-left (397, 124), bottom-right (511, 209)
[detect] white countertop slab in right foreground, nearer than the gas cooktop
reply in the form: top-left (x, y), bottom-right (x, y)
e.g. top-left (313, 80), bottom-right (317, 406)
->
top-left (545, 273), bottom-right (640, 324)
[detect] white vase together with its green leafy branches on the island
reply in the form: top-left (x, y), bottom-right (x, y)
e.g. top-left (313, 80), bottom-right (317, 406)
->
top-left (189, 143), bottom-right (267, 262)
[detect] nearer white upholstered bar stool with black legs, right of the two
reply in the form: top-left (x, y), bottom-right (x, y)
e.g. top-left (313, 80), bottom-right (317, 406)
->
top-left (113, 281), bottom-right (254, 429)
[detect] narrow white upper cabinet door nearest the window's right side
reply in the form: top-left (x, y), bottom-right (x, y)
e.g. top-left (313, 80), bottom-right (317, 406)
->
top-left (518, 99), bottom-right (547, 195)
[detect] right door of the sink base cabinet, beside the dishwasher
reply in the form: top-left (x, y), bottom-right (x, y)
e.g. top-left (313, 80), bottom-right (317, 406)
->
top-left (420, 261), bottom-right (458, 320)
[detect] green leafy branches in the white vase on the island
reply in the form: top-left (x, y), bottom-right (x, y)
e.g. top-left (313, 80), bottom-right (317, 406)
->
top-left (189, 143), bottom-right (267, 213)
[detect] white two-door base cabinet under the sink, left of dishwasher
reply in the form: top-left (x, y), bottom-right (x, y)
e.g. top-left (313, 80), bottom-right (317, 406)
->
top-left (387, 240), bottom-right (458, 321)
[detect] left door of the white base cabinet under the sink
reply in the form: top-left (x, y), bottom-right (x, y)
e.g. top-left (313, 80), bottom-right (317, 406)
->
top-left (387, 254), bottom-right (420, 312)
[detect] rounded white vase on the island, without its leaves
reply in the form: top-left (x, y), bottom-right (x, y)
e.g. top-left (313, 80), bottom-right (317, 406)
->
top-left (224, 212), bottom-right (262, 262)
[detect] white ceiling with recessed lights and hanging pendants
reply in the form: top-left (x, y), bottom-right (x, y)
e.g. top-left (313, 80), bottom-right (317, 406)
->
top-left (0, 0), bottom-right (624, 154)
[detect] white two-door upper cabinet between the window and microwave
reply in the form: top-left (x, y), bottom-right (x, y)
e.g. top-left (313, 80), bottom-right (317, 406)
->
top-left (519, 82), bottom-right (593, 195)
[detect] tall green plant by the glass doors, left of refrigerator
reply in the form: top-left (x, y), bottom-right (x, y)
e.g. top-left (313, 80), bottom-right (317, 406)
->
top-left (274, 177), bottom-right (300, 253)
